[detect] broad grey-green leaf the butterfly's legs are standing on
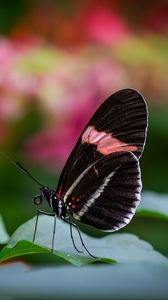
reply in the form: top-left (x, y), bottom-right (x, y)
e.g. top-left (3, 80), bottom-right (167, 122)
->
top-left (0, 215), bottom-right (167, 266)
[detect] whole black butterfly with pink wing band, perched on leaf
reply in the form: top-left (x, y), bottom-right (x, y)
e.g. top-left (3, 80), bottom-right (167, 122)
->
top-left (0, 89), bottom-right (148, 256)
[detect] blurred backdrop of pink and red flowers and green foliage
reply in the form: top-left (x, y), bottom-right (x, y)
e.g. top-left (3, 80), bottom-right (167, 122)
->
top-left (0, 0), bottom-right (168, 253)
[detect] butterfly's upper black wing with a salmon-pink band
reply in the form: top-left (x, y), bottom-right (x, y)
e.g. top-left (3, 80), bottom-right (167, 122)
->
top-left (57, 89), bottom-right (147, 201)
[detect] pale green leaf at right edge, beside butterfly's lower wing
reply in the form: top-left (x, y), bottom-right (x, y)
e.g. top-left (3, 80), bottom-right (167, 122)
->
top-left (137, 192), bottom-right (168, 221)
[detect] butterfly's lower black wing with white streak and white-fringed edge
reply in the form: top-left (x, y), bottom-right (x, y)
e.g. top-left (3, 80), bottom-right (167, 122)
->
top-left (67, 152), bottom-right (141, 231)
